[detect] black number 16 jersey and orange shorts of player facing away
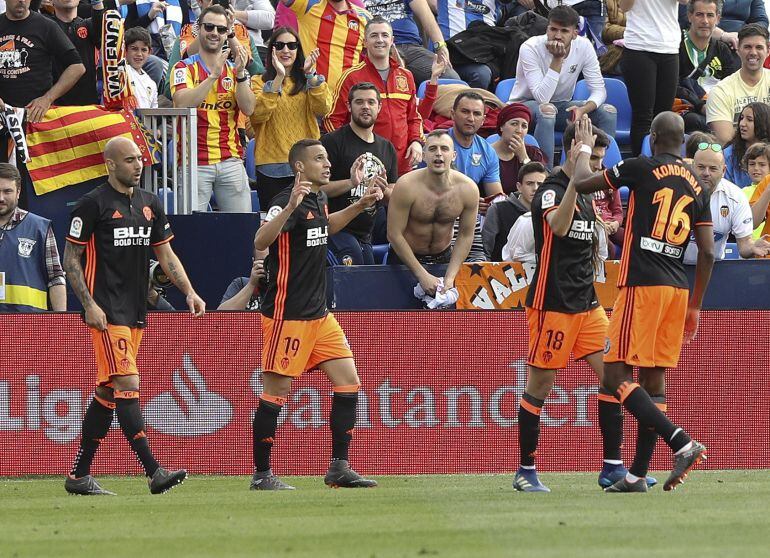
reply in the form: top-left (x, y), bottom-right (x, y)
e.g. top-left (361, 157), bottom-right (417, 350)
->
top-left (604, 154), bottom-right (712, 368)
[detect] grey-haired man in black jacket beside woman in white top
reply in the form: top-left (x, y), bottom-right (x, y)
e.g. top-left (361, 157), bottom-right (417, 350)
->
top-left (674, 0), bottom-right (740, 134)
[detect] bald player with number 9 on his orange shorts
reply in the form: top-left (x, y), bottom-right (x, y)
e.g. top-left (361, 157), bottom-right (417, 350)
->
top-left (64, 137), bottom-right (206, 495)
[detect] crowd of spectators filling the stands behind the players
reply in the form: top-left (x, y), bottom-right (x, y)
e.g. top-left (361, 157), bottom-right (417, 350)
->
top-left (0, 0), bottom-right (770, 310)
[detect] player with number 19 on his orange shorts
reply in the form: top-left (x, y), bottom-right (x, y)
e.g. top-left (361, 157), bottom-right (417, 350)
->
top-left (251, 139), bottom-right (382, 490)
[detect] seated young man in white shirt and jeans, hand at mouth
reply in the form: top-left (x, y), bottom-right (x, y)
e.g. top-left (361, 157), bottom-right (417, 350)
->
top-left (511, 6), bottom-right (618, 167)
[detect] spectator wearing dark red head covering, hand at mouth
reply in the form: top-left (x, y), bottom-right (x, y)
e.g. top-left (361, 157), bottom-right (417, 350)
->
top-left (492, 103), bottom-right (548, 194)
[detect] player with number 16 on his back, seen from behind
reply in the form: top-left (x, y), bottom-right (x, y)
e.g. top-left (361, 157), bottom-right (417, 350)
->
top-left (574, 112), bottom-right (714, 492)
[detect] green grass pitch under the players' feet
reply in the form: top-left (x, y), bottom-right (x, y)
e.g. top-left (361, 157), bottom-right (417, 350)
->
top-left (0, 470), bottom-right (770, 558)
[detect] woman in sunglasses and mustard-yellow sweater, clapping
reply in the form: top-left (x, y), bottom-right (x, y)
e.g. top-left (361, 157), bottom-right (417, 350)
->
top-left (250, 27), bottom-right (332, 208)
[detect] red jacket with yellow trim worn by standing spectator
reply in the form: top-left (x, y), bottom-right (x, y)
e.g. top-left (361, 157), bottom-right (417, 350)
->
top-left (324, 55), bottom-right (423, 175)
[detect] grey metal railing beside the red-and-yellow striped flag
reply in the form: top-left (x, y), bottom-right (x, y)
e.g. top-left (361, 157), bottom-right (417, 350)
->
top-left (137, 108), bottom-right (198, 215)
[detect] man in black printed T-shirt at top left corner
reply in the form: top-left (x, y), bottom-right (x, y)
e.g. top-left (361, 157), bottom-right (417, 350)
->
top-left (0, 0), bottom-right (86, 123)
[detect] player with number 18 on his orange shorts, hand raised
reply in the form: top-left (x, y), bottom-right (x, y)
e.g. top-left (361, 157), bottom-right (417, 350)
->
top-left (513, 121), bottom-right (640, 492)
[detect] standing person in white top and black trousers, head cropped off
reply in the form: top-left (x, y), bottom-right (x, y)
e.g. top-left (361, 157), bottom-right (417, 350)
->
top-left (620, 0), bottom-right (687, 156)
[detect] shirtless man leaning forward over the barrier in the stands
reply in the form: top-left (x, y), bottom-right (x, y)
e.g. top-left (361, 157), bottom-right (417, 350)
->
top-left (388, 130), bottom-right (479, 296)
